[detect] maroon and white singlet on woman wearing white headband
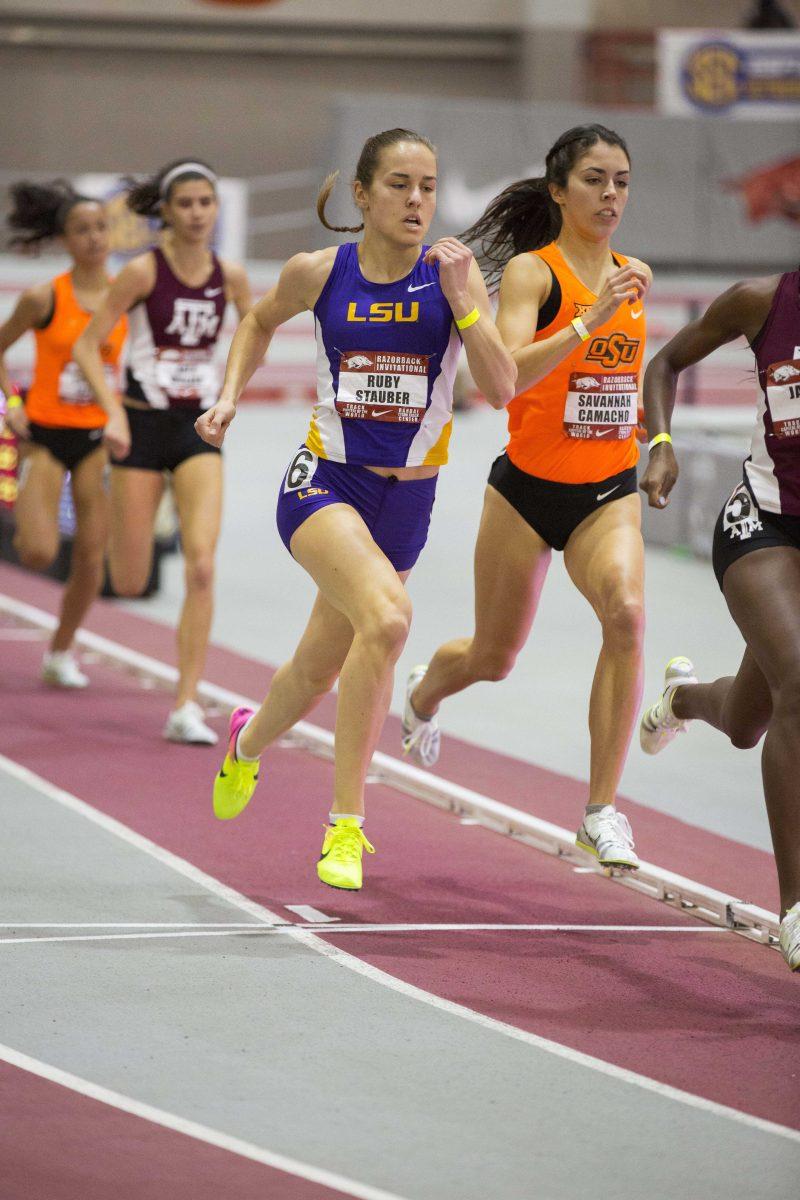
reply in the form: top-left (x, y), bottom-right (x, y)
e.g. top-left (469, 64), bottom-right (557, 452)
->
top-left (125, 248), bottom-right (225, 412)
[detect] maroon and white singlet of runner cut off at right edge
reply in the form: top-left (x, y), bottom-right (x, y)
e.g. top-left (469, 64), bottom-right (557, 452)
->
top-left (745, 271), bottom-right (800, 516)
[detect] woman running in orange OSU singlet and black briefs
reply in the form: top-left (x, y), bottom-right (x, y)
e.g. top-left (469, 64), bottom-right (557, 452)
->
top-left (403, 125), bottom-right (651, 869)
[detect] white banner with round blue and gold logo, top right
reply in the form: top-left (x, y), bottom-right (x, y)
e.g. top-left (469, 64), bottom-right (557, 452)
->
top-left (656, 29), bottom-right (800, 121)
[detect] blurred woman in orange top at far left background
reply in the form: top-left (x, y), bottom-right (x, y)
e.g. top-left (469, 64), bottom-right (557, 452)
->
top-left (0, 180), bottom-right (127, 688)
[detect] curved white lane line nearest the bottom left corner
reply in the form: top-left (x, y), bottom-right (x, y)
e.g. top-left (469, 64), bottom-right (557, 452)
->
top-left (0, 1044), bottom-right (405, 1200)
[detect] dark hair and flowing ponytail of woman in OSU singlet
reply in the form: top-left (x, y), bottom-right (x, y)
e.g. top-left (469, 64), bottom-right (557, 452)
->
top-left (461, 125), bottom-right (631, 284)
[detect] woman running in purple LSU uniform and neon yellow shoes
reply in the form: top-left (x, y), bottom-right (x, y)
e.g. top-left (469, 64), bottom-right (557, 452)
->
top-left (198, 130), bottom-right (516, 889)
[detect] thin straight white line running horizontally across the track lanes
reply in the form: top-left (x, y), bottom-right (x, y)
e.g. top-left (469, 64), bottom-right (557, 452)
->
top-left (0, 918), bottom-right (733, 946)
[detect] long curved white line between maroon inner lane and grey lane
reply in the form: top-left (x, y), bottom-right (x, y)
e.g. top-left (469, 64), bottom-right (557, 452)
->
top-left (0, 755), bottom-right (800, 1145)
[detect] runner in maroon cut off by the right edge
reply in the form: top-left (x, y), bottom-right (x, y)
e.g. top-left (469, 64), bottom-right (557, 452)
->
top-left (640, 270), bottom-right (800, 971)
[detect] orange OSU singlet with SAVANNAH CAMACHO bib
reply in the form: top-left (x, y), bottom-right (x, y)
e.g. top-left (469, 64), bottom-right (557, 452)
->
top-left (507, 241), bottom-right (645, 484)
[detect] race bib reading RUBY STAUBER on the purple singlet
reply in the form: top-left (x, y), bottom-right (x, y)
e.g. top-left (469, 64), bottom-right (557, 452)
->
top-left (336, 350), bottom-right (428, 425)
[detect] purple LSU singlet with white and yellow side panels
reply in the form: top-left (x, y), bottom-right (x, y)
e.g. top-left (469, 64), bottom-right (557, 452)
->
top-left (306, 242), bottom-right (461, 467)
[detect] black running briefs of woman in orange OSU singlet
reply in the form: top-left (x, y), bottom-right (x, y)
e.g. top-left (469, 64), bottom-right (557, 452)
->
top-left (489, 454), bottom-right (637, 550)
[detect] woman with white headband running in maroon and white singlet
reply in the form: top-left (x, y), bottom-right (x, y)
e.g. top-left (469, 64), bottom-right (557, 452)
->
top-left (74, 160), bottom-right (251, 744)
